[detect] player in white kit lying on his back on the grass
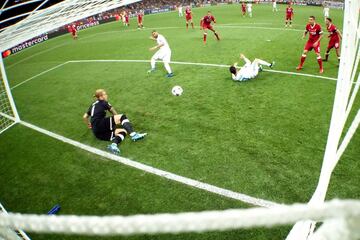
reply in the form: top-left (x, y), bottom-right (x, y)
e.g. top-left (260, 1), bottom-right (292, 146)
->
top-left (229, 54), bottom-right (275, 81)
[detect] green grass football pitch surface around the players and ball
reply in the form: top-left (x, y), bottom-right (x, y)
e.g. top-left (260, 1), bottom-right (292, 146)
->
top-left (0, 2), bottom-right (360, 240)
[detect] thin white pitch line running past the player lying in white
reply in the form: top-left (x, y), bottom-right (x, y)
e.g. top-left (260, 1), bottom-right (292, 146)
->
top-left (68, 59), bottom-right (337, 81)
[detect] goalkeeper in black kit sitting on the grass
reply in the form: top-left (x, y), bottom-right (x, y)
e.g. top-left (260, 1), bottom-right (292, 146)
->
top-left (83, 89), bottom-right (146, 155)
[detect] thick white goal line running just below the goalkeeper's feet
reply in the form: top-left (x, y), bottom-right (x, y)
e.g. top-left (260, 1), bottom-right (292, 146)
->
top-left (2, 114), bottom-right (280, 208)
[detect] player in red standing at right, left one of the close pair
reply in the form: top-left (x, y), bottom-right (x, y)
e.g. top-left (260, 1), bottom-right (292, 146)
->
top-left (296, 16), bottom-right (324, 73)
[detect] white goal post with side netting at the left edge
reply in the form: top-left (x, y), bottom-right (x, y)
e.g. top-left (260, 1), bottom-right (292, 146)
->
top-left (0, 56), bottom-right (20, 134)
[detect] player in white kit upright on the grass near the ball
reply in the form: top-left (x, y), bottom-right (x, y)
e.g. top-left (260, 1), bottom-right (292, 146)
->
top-left (148, 30), bottom-right (174, 78)
